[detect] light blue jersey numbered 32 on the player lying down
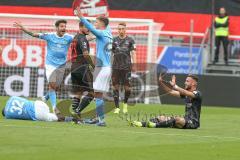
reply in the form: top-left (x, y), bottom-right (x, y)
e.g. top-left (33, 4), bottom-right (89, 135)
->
top-left (4, 96), bottom-right (37, 121)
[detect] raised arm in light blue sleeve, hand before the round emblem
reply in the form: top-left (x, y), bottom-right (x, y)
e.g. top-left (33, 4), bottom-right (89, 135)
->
top-left (75, 7), bottom-right (103, 37)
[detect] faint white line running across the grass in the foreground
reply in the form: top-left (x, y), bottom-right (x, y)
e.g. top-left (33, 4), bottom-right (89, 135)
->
top-left (0, 125), bottom-right (240, 140)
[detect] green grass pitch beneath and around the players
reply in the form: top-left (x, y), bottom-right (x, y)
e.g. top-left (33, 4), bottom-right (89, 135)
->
top-left (0, 97), bottom-right (240, 160)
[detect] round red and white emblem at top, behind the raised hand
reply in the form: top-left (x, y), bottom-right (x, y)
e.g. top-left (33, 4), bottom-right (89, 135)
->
top-left (72, 0), bottom-right (108, 16)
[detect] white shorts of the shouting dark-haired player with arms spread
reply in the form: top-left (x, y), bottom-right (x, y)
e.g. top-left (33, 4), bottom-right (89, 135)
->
top-left (45, 64), bottom-right (65, 85)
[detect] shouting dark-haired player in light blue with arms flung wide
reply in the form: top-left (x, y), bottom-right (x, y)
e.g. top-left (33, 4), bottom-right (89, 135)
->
top-left (15, 20), bottom-right (73, 113)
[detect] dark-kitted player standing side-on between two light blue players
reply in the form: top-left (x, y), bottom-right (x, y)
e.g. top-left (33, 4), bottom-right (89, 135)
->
top-left (71, 22), bottom-right (95, 114)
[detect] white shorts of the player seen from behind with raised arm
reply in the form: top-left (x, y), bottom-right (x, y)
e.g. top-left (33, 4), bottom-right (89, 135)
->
top-left (93, 67), bottom-right (112, 93)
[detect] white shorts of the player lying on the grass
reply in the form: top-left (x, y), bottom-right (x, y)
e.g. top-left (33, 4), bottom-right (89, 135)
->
top-left (34, 101), bottom-right (58, 122)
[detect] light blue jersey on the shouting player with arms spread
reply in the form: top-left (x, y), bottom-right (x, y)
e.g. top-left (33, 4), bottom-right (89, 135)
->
top-left (39, 33), bottom-right (73, 67)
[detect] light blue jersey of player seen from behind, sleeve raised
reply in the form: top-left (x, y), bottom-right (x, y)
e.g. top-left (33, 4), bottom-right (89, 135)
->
top-left (81, 18), bottom-right (113, 67)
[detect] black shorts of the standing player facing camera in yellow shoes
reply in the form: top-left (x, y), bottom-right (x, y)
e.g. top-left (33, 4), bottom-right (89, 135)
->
top-left (112, 69), bottom-right (131, 87)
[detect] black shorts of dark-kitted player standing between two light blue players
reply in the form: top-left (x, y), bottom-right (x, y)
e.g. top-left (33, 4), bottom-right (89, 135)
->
top-left (71, 66), bottom-right (93, 93)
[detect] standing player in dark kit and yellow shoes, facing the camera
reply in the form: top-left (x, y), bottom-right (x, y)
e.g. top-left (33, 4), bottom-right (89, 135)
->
top-left (112, 23), bottom-right (136, 114)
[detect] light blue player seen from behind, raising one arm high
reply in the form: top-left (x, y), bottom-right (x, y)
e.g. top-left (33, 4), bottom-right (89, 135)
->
top-left (76, 7), bottom-right (113, 126)
